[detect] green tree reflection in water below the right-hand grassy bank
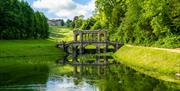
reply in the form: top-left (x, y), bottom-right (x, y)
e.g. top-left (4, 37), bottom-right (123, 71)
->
top-left (97, 65), bottom-right (180, 91)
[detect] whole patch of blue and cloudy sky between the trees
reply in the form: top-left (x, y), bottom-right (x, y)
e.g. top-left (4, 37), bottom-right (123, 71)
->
top-left (25, 0), bottom-right (95, 20)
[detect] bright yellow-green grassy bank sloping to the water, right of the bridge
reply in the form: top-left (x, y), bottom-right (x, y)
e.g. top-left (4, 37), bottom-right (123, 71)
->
top-left (114, 45), bottom-right (180, 83)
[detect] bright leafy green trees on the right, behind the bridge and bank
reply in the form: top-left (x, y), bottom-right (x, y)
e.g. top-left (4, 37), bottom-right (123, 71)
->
top-left (73, 0), bottom-right (180, 47)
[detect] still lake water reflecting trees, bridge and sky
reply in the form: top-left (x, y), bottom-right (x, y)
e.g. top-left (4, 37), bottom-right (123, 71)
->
top-left (0, 55), bottom-right (180, 91)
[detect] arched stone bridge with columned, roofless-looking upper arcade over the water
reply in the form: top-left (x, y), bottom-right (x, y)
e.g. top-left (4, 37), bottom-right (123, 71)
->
top-left (57, 30), bottom-right (123, 54)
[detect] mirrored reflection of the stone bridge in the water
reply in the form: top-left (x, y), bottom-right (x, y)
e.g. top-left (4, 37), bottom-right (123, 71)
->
top-left (59, 55), bottom-right (120, 77)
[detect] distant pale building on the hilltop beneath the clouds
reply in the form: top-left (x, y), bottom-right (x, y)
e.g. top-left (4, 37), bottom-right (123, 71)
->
top-left (48, 19), bottom-right (64, 26)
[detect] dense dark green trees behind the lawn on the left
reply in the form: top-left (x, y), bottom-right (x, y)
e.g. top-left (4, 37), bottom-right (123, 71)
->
top-left (0, 0), bottom-right (49, 39)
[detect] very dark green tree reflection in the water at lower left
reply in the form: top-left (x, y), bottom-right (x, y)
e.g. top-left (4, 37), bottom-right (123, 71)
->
top-left (0, 64), bottom-right (49, 86)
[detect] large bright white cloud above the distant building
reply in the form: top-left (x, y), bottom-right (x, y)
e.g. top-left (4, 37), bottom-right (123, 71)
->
top-left (32, 0), bottom-right (95, 19)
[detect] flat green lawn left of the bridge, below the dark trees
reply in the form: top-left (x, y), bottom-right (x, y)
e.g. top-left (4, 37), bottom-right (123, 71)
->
top-left (0, 40), bottom-right (64, 58)
